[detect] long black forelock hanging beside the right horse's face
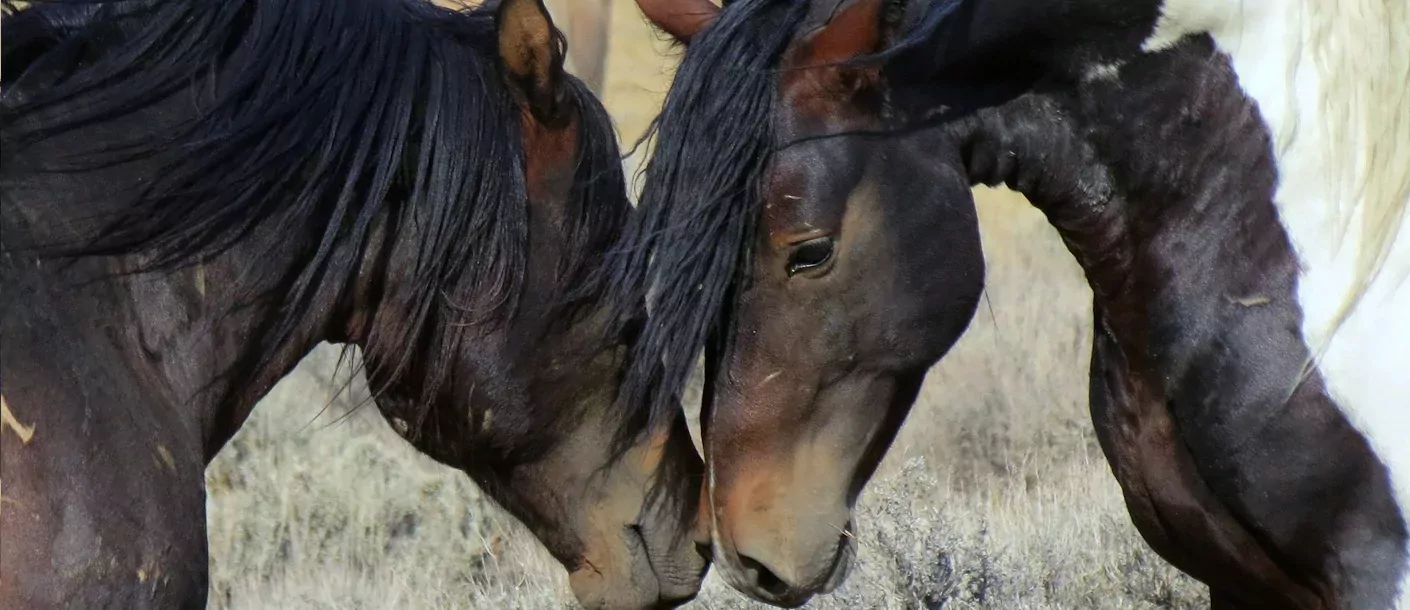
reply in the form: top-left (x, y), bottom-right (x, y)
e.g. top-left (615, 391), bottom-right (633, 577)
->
top-left (608, 0), bottom-right (807, 445)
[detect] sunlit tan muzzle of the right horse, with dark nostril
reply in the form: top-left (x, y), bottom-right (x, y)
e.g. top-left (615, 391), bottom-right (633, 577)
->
top-left (705, 356), bottom-right (909, 607)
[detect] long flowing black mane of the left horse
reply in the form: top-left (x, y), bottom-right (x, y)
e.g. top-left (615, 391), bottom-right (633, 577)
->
top-left (0, 0), bottom-right (630, 408)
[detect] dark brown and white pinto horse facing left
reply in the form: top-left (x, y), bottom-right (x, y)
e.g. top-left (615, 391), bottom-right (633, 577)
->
top-left (616, 0), bottom-right (1410, 610)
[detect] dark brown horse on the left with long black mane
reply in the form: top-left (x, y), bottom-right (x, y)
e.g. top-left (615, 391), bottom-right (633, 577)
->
top-left (0, 0), bottom-right (705, 609)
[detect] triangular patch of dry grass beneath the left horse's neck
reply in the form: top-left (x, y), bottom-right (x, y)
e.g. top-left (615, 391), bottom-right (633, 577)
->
top-left (206, 347), bottom-right (567, 609)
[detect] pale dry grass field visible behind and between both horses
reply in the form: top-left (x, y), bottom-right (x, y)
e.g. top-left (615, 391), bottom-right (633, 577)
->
top-left (207, 0), bottom-right (1207, 610)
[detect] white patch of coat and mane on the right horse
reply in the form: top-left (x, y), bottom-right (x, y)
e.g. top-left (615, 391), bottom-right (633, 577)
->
top-left (1146, 5), bottom-right (1410, 588)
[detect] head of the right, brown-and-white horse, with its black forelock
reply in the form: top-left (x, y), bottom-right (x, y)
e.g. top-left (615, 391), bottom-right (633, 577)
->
top-left (618, 1), bottom-right (984, 604)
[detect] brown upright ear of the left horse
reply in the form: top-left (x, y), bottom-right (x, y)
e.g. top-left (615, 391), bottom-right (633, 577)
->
top-left (495, 0), bottom-right (567, 123)
